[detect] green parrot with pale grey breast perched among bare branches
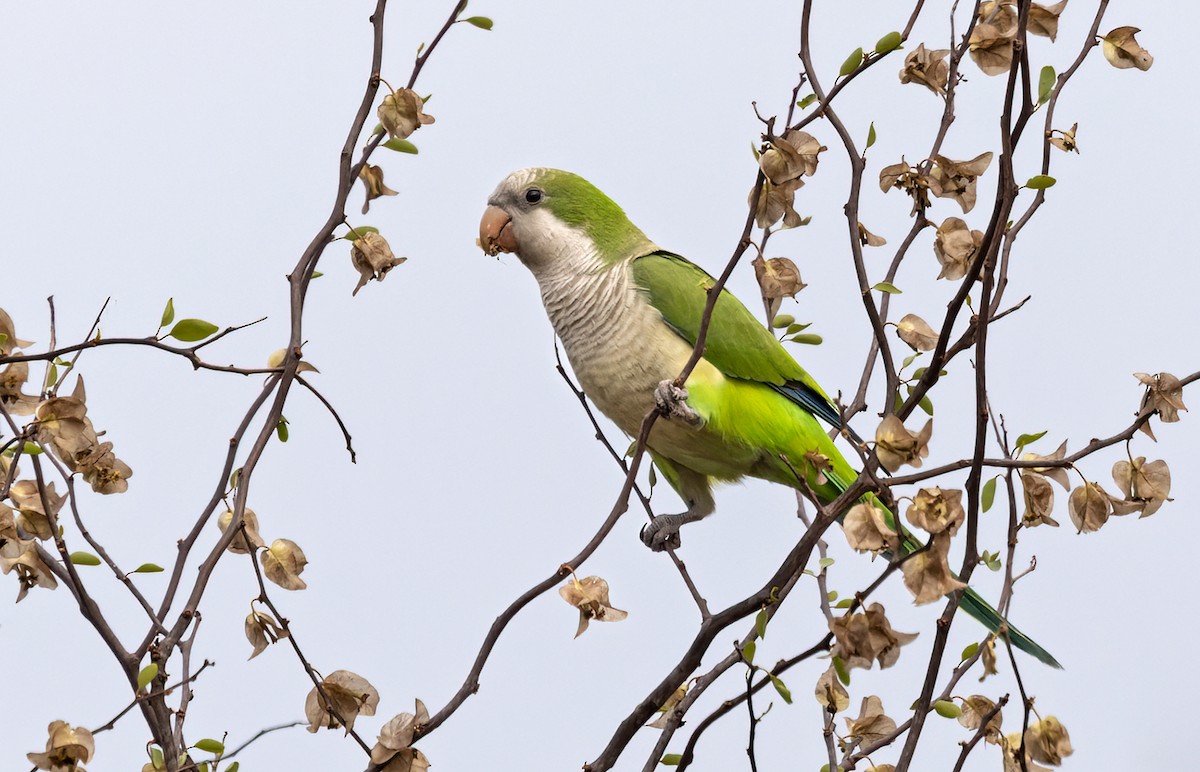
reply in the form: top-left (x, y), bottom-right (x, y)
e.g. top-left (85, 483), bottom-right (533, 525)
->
top-left (480, 168), bottom-right (1061, 668)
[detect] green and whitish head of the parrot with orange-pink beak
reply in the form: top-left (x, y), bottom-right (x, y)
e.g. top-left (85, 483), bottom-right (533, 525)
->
top-left (479, 168), bottom-right (654, 273)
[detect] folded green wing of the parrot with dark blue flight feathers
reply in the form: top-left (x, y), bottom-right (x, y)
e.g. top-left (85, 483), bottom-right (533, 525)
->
top-left (630, 251), bottom-right (841, 427)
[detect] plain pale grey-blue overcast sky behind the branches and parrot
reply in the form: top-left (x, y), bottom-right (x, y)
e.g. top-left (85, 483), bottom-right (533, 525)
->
top-left (0, 0), bottom-right (1200, 772)
